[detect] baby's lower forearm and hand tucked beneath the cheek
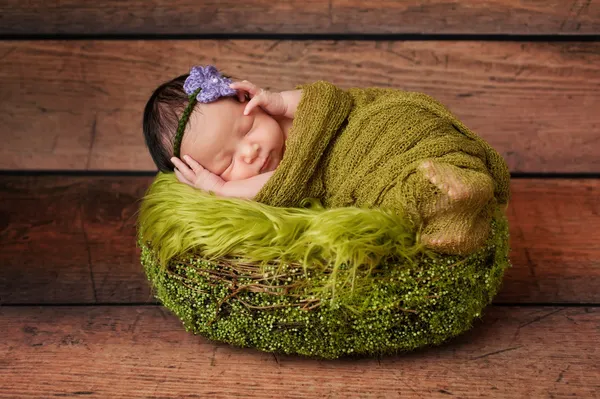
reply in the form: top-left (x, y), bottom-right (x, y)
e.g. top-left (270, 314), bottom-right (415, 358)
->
top-left (171, 155), bottom-right (275, 199)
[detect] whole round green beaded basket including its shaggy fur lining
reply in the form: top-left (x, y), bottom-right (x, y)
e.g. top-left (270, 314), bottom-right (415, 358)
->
top-left (138, 173), bottom-right (510, 358)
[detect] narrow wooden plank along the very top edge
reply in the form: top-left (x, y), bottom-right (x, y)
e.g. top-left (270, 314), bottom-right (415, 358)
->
top-left (0, 0), bottom-right (600, 35)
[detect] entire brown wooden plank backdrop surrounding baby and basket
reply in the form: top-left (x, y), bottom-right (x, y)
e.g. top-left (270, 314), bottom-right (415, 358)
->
top-left (0, 0), bottom-right (600, 398)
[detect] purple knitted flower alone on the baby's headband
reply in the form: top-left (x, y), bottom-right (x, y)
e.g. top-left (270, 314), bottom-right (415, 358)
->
top-left (183, 65), bottom-right (236, 103)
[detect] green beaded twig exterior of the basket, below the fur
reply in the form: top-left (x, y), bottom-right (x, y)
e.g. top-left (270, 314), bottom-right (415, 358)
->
top-left (140, 206), bottom-right (510, 358)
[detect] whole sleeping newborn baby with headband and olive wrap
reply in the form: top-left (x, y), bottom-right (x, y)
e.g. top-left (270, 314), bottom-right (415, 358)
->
top-left (144, 66), bottom-right (509, 254)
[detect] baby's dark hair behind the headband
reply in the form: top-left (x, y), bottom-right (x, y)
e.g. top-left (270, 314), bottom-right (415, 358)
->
top-left (143, 74), bottom-right (189, 172)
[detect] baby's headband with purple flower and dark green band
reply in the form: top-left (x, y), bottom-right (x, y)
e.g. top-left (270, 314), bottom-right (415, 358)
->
top-left (173, 65), bottom-right (236, 158)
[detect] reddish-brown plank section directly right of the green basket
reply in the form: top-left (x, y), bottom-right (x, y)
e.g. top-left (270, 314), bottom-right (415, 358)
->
top-left (496, 179), bottom-right (600, 303)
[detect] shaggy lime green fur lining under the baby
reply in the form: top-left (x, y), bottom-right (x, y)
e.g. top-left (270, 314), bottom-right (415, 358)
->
top-left (138, 173), bottom-right (431, 298)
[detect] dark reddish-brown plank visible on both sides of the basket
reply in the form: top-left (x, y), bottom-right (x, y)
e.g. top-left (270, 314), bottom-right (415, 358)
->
top-left (0, 176), bottom-right (600, 305)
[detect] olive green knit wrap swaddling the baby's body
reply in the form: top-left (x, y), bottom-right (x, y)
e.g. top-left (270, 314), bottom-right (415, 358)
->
top-left (254, 81), bottom-right (510, 254)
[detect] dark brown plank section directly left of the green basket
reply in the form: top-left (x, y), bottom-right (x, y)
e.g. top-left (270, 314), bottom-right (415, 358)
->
top-left (0, 176), bottom-right (153, 303)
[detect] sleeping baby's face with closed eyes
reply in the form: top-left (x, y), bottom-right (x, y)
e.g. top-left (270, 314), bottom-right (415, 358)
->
top-left (180, 97), bottom-right (285, 181)
